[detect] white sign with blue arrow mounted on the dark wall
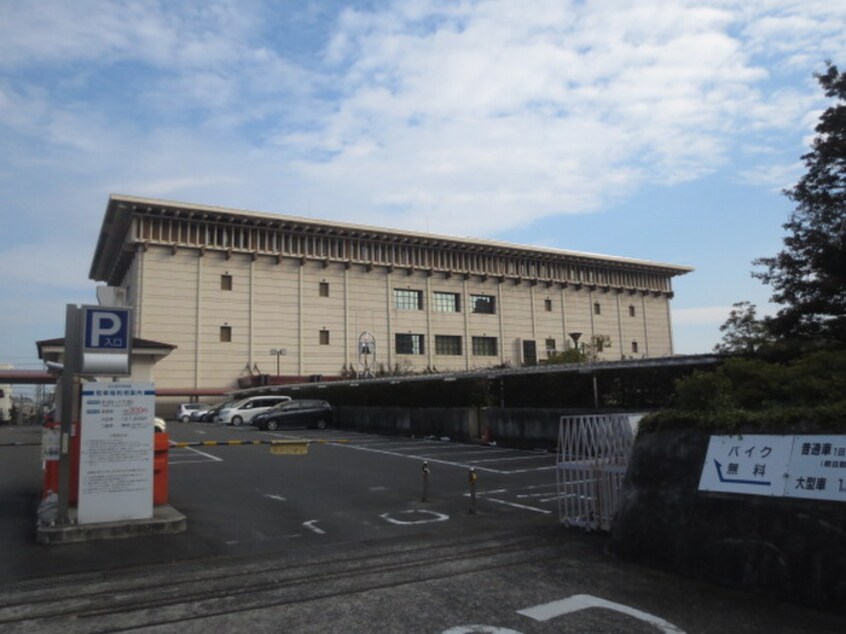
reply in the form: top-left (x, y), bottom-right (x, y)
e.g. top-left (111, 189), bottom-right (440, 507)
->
top-left (699, 434), bottom-right (846, 502)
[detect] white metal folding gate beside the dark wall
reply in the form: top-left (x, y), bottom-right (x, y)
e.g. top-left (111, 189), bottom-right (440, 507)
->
top-left (555, 414), bottom-right (640, 531)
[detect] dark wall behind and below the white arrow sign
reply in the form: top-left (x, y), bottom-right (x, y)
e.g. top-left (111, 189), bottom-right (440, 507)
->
top-left (609, 431), bottom-right (846, 613)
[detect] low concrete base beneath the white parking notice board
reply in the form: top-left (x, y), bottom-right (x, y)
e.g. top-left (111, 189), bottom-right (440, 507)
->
top-left (35, 504), bottom-right (188, 544)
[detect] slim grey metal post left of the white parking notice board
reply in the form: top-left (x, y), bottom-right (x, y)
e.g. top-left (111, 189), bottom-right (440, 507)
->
top-left (56, 304), bottom-right (80, 526)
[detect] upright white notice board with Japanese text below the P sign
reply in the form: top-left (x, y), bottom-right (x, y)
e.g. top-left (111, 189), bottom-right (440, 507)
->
top-left (78, 383), bottom-right (155, 524)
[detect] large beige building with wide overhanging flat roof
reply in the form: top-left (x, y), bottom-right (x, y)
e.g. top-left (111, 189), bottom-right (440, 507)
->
top-left (90, 195), bottom-right (692, 394)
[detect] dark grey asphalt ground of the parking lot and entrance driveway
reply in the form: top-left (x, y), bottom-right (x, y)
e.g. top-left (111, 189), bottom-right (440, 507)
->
top-left (0, 422), bottom-right (846, 634)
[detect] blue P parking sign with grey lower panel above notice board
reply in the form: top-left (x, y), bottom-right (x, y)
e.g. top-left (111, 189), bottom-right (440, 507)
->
top-left (80, 306), bottom-right (132, 376)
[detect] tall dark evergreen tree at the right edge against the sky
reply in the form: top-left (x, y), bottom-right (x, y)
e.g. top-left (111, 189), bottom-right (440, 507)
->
top-left (752, 62), bottom-right (846, 342)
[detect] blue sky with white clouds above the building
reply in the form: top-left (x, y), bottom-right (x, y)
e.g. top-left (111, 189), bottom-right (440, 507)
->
top-left (0, 0), bottom-right (846, 368)
